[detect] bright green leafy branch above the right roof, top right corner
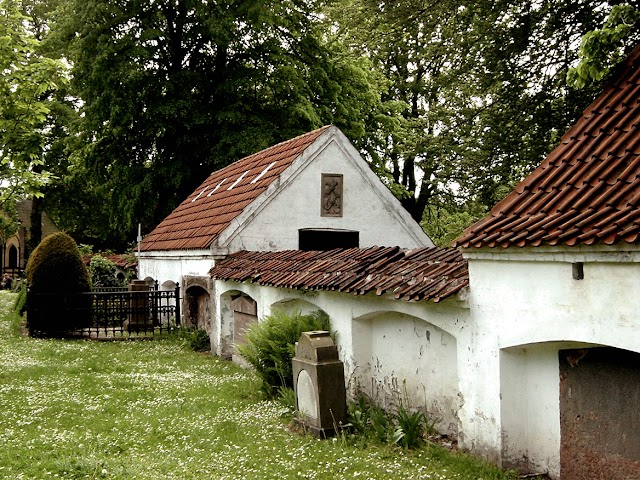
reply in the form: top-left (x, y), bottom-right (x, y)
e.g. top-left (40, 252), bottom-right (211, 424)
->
top-left (567, 3), bottom-right (640, 88)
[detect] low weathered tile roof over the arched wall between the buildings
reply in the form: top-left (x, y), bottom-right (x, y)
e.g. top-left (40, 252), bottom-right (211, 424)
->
top-left (209, 247), bottom-right (469, 302)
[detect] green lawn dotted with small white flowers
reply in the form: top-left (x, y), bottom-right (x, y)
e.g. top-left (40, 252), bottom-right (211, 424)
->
top-left (0, 292), bottom-right (517, 480)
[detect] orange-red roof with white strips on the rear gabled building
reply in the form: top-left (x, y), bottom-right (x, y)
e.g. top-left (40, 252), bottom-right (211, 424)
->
top-left (141, 126), bottom-right (329, 251)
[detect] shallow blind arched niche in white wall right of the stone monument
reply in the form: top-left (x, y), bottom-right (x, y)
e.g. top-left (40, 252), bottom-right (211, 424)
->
top-left (349, 311), bottom-right (461, 436)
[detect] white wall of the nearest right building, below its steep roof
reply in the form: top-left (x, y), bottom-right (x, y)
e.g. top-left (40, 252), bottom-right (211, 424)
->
top-left (457, 247), bottom-right (640, 478)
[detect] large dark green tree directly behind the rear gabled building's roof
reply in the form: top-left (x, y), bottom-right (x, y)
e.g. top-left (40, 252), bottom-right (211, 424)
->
top-left (48, 0), bottom-right (377, 248)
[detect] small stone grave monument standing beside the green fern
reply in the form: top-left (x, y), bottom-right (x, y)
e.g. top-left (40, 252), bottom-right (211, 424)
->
top-left (292, 331), bottom-right (347, 438)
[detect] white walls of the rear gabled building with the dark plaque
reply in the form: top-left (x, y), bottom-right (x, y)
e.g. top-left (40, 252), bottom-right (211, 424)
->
top-left (138, 127), bottom-right (433, 283)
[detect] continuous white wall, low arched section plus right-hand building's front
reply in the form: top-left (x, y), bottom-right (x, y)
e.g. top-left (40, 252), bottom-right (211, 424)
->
top-left (206, 246), bottom-right (640, 479)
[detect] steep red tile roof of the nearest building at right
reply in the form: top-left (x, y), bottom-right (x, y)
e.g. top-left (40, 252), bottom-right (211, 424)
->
top-left (454, 45), bottom-right (640, 248)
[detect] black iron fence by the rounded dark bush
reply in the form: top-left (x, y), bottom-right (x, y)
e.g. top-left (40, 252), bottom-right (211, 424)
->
top-left (27, 285), bottom-right (180, 338)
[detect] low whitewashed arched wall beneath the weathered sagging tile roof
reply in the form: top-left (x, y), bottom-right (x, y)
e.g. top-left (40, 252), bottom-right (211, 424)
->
top-left (212, 281), bottom-right (468, 435)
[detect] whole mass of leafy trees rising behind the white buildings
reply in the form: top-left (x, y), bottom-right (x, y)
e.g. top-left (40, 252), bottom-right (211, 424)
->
top-left (10, 0), bottom-right (640, 249)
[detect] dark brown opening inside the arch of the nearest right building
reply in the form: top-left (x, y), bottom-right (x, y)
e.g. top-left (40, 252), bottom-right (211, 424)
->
top-left (560, 347), bottom-right (640, 480)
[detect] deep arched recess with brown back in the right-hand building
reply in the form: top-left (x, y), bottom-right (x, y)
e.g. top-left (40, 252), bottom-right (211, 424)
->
top-left (499, 340), bottom-right (640, 480)
